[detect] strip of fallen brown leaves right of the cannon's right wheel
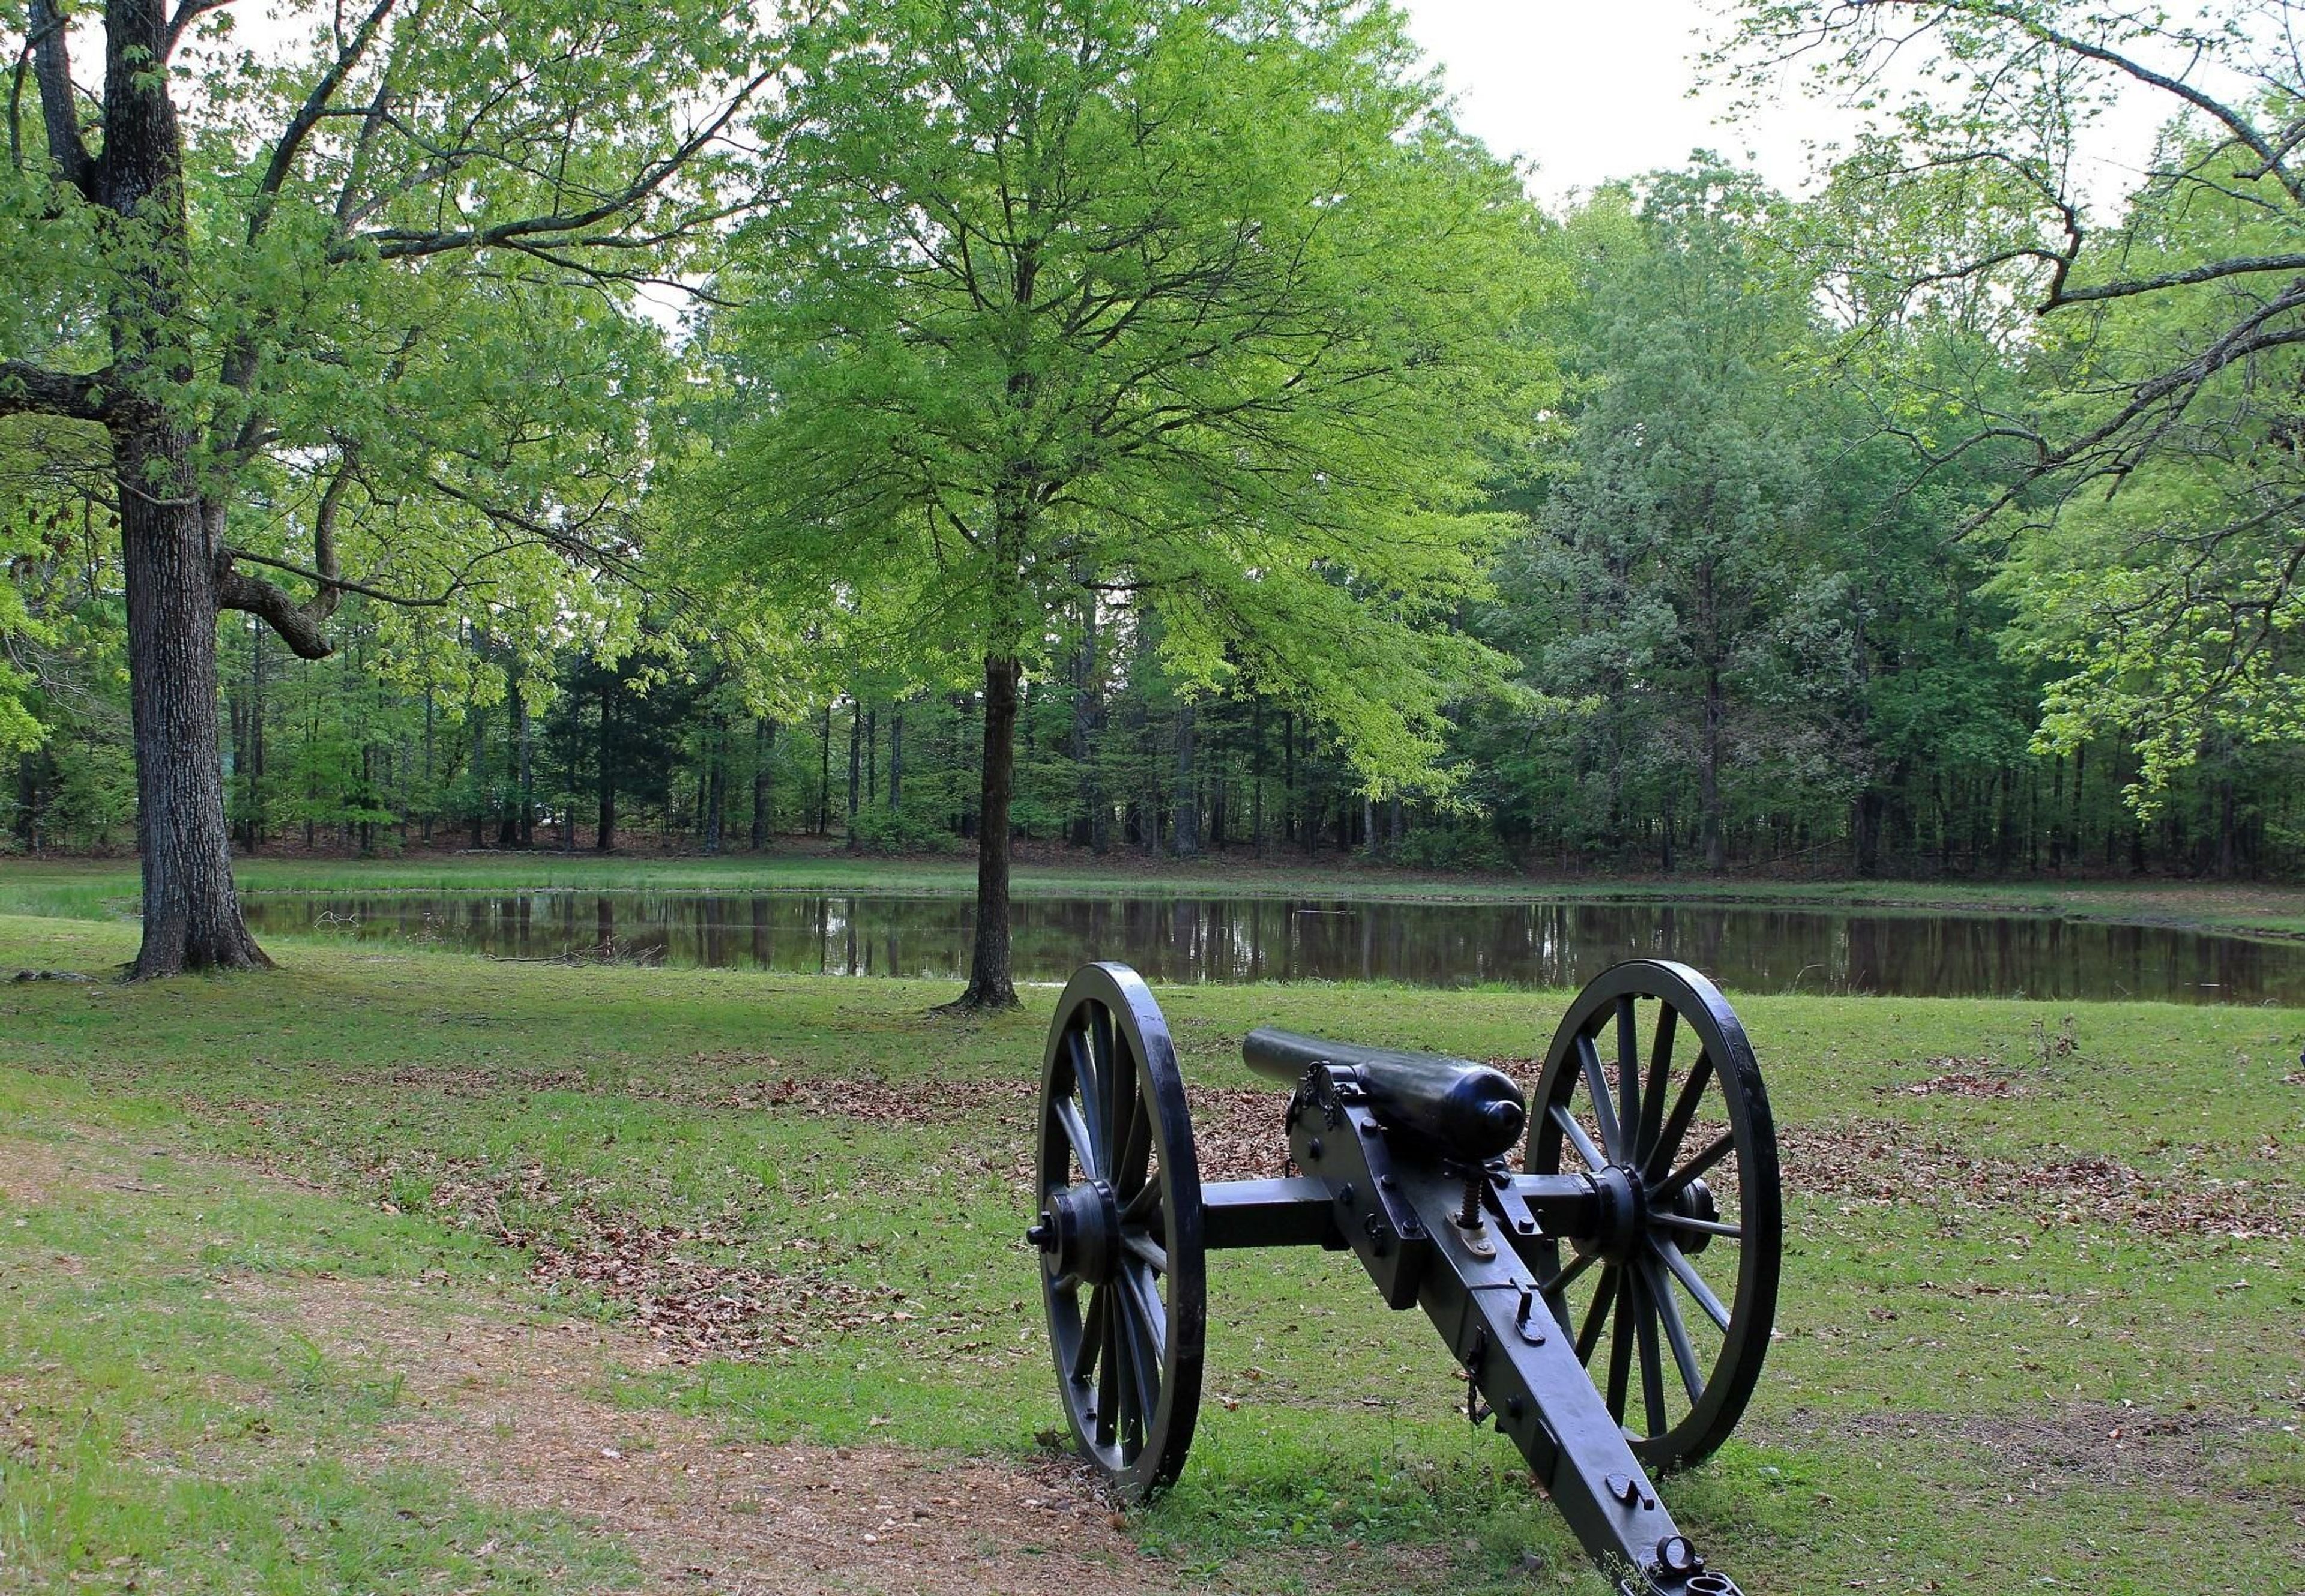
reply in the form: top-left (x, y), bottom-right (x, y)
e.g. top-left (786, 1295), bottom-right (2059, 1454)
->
top-left (1777, 1121), bottom-right (2298, 1241)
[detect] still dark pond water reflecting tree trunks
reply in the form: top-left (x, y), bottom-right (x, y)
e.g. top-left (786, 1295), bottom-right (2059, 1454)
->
top-left (244, 890), bottom-right (2305, 1003)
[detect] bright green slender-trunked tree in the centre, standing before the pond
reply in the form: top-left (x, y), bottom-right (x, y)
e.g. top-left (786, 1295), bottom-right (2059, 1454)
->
top-left (692, 0), bottom-right (1535, 1005)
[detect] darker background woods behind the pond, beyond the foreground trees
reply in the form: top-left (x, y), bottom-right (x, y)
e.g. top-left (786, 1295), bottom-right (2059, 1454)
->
top-left (7, 166), bottom-right (2305, 874)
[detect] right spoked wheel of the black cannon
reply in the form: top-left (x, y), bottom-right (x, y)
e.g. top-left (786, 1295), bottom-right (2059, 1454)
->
top-left (1528, 959), bottom-right (1784, 1474)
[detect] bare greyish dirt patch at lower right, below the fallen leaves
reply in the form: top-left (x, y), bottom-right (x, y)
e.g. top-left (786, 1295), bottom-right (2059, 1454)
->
top-left (1754, 1402), bottom-right (2270, 1495)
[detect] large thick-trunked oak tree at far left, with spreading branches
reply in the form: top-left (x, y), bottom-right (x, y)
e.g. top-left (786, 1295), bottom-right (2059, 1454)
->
top-left (0, 0), bottom-right (763, 975)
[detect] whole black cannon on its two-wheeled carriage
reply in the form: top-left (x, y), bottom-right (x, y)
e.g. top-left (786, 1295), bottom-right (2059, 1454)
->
top-left (1026, 959), bottom-right (1782, 1596)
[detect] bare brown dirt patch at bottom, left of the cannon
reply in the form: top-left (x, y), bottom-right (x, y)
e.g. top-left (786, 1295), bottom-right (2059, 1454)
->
top-left (217, 1280), bottom-right (1174, 1596)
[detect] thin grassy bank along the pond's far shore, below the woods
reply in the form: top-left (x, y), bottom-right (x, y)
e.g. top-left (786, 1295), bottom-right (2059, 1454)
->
top-left (0, 844), bottom-right (2305, 939)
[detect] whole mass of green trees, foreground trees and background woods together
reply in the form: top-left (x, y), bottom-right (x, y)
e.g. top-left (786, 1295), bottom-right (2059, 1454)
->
top-left (0, 0), bottom-right (2305, 1001)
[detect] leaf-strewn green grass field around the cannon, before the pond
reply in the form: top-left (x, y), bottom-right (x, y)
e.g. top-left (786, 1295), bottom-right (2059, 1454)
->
top-left (0, 904), bottom-right (2305, 1596)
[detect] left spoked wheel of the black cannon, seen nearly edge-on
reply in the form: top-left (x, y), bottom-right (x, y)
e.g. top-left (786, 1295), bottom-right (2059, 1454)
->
top-left (1028, 964), bottom-right (1208, 1501)
